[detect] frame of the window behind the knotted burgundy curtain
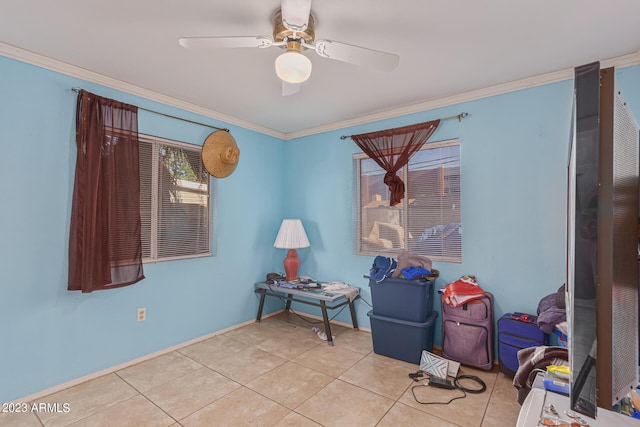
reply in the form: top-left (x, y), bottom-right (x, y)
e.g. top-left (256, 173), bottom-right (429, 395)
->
top-left (353, 138), bottom-right (463, 263)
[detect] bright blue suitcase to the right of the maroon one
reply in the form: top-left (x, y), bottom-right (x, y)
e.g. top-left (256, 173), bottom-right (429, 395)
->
top-left (498, 313), bottom-right (549, 378)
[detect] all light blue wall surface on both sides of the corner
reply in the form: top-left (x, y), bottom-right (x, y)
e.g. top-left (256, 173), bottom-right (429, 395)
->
top-left (0, 51), bottom-right (640, 402)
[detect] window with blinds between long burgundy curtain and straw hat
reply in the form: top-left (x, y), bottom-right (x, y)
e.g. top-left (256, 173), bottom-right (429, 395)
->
top-left (140, 135), bottom-right (212, 262)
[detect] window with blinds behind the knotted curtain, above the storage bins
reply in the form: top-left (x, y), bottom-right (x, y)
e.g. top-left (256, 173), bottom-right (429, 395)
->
top-left (354, 140), bottom-right (462, 262)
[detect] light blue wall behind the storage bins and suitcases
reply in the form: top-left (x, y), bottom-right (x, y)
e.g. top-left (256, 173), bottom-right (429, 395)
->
top-left (286, 81), bottom-right (573, 343)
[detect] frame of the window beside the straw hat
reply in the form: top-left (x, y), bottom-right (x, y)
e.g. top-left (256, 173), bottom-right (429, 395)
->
top-left (138, 133), bottom-right (217, 264)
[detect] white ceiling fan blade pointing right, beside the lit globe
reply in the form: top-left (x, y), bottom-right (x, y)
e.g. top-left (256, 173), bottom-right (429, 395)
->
top-left (315, 40), bottom-right (400, 71)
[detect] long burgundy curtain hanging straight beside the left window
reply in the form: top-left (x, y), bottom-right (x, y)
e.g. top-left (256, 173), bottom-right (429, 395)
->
top-left (68, 90), bottom-right (144, 292)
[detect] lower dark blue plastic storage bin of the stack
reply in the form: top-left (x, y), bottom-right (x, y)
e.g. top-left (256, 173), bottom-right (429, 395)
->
top-left (367, 310), bottom-right (438, 365)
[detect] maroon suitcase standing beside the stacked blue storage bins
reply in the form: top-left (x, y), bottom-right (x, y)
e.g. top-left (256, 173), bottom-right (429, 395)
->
top-left (441, 292), bottom-right (494, 370)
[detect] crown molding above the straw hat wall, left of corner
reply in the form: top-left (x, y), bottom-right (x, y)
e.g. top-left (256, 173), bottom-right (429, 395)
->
top-left (0, 42), bottom-right (286, 139)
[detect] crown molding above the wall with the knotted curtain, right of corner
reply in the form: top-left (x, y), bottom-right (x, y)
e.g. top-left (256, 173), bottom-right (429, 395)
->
top-left (286, 52), bottom-right (640, 140)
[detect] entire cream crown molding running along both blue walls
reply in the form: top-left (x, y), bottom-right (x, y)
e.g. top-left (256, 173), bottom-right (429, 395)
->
top-left (0, 42), bottom-right (640, 141)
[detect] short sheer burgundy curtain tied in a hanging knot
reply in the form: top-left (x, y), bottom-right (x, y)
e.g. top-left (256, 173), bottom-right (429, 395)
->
top-left (351, 120), bottom-right (440, 206)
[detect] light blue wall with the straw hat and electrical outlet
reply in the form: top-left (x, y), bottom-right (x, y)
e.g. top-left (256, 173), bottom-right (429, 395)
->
top-left (0, 57), bottom-right (285, 402)
